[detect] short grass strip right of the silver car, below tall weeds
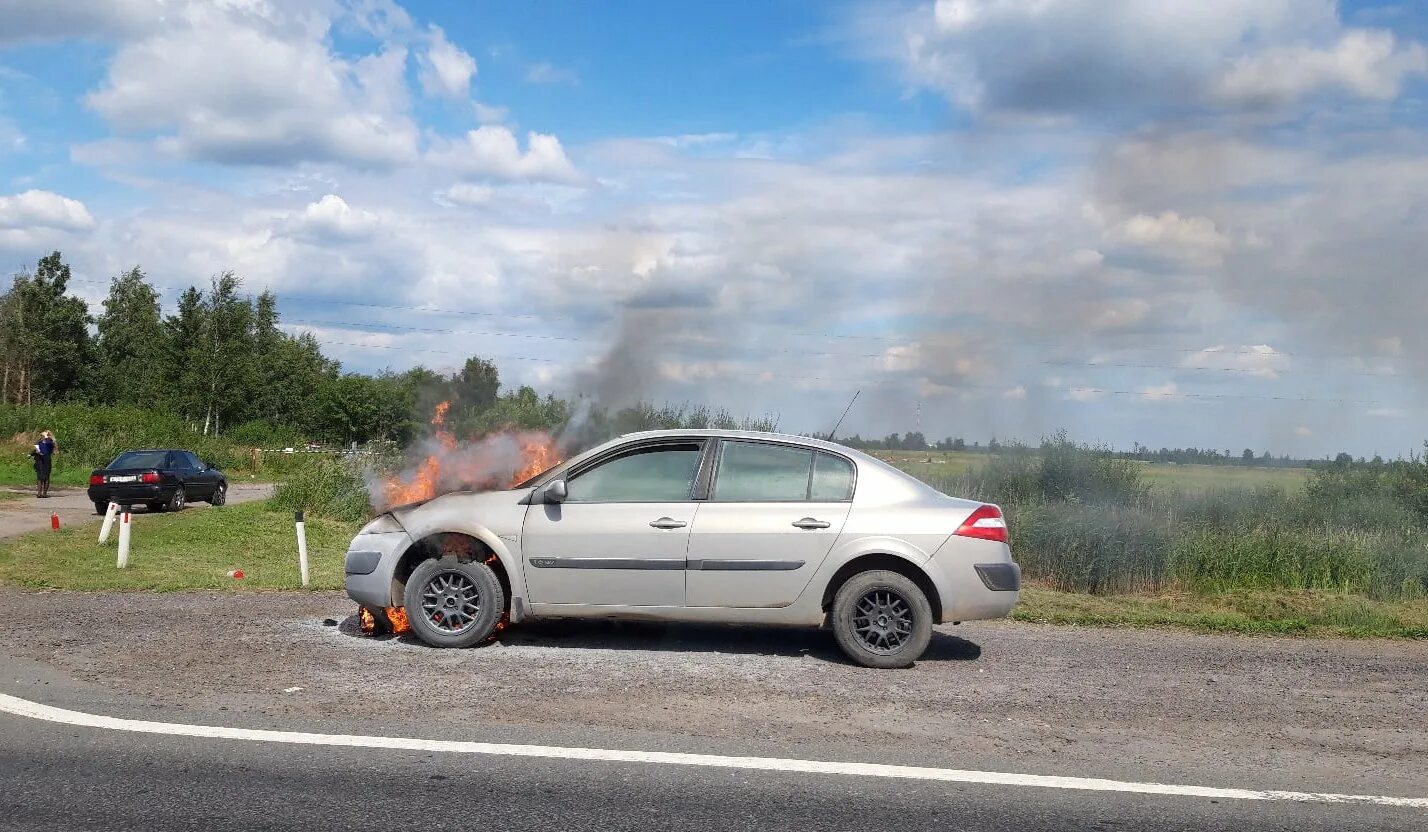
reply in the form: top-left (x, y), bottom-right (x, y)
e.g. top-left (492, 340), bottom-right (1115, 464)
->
top-left (1012, 585), bottom-right (1428, 638)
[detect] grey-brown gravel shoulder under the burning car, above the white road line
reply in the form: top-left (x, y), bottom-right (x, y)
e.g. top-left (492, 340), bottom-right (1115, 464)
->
top-left (0, 587), bottom-right (1428, 796)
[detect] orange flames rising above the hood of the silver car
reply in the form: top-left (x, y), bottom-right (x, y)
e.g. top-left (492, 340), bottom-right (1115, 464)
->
top-left (381, 401), bottom-right (561, 505)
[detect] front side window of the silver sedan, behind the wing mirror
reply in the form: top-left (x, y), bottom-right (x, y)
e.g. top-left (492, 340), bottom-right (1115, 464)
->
top-left (565, 442), bottom-right (704, 502)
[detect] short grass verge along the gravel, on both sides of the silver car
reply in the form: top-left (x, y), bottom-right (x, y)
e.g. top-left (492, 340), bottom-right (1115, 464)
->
top-left (0, 504), bottom-right (1428, 638)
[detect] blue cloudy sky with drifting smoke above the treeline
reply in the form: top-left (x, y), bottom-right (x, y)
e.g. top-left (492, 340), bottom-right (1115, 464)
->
top-left (0, 0), bottom-right (1428, 455)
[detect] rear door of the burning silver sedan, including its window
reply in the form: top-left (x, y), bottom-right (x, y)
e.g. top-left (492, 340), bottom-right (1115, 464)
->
top-left (684, 440), bottom-right (854, 607)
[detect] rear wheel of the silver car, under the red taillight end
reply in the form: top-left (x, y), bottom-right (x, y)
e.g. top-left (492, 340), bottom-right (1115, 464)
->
top-left (833, 569), bottom-right (932, 669)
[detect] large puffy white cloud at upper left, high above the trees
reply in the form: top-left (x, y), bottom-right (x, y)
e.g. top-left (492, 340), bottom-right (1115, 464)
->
top-left (86, 3), bottom-right (417, 164)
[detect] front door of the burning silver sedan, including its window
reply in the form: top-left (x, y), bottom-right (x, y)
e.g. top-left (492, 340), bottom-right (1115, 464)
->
top-left (521, 441), bottom-right (705, 607)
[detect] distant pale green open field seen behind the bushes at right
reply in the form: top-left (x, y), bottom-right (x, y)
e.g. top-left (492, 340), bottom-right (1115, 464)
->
top-left (874, 451), bottom-right (1309, 494)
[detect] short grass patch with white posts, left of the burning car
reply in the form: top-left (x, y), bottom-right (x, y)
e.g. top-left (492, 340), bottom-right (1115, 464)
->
top-left (0, 502), bottom-right (357, 591)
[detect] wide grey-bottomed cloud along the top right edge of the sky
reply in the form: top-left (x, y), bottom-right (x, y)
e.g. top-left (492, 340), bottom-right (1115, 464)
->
top-left (863, 0), bottom-right (1424, 114)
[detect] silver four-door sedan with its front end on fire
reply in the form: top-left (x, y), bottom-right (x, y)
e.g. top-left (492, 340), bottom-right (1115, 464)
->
top-left (346, 431), bottom-right (1021, 668)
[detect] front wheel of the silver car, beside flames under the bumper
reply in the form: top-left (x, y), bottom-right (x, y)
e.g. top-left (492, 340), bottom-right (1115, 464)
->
top-left (403, 558), bottom-right (506, 646)
